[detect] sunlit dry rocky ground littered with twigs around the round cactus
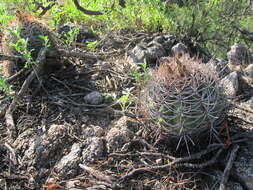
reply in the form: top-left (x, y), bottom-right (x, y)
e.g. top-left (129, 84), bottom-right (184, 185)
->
top-left (0, 28), bottom-right (253, 190)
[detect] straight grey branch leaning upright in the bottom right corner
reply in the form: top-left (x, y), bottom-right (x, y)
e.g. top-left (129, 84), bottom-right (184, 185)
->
top-left (219, 145), bottom-right (239, 190)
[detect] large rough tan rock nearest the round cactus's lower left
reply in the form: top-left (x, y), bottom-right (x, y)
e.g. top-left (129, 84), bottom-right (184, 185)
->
top-left (106, 116), bottom-right (133, 153)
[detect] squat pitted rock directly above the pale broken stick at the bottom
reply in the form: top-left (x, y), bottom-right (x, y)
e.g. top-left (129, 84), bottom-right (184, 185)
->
top-left (82, 137), bottom-right (106, 163)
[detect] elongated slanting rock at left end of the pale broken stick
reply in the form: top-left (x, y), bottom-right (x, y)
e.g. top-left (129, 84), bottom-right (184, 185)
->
top-left (54, 143), bottom-right (82, 179)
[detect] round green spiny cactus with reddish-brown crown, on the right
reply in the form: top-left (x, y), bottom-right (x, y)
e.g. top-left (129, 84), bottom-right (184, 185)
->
top-left (141, 55), bottom-right (228, 143)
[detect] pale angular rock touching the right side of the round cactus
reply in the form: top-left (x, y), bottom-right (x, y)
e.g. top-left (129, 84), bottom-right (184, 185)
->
top-left (220, 71), bottom-right (239, 97)
